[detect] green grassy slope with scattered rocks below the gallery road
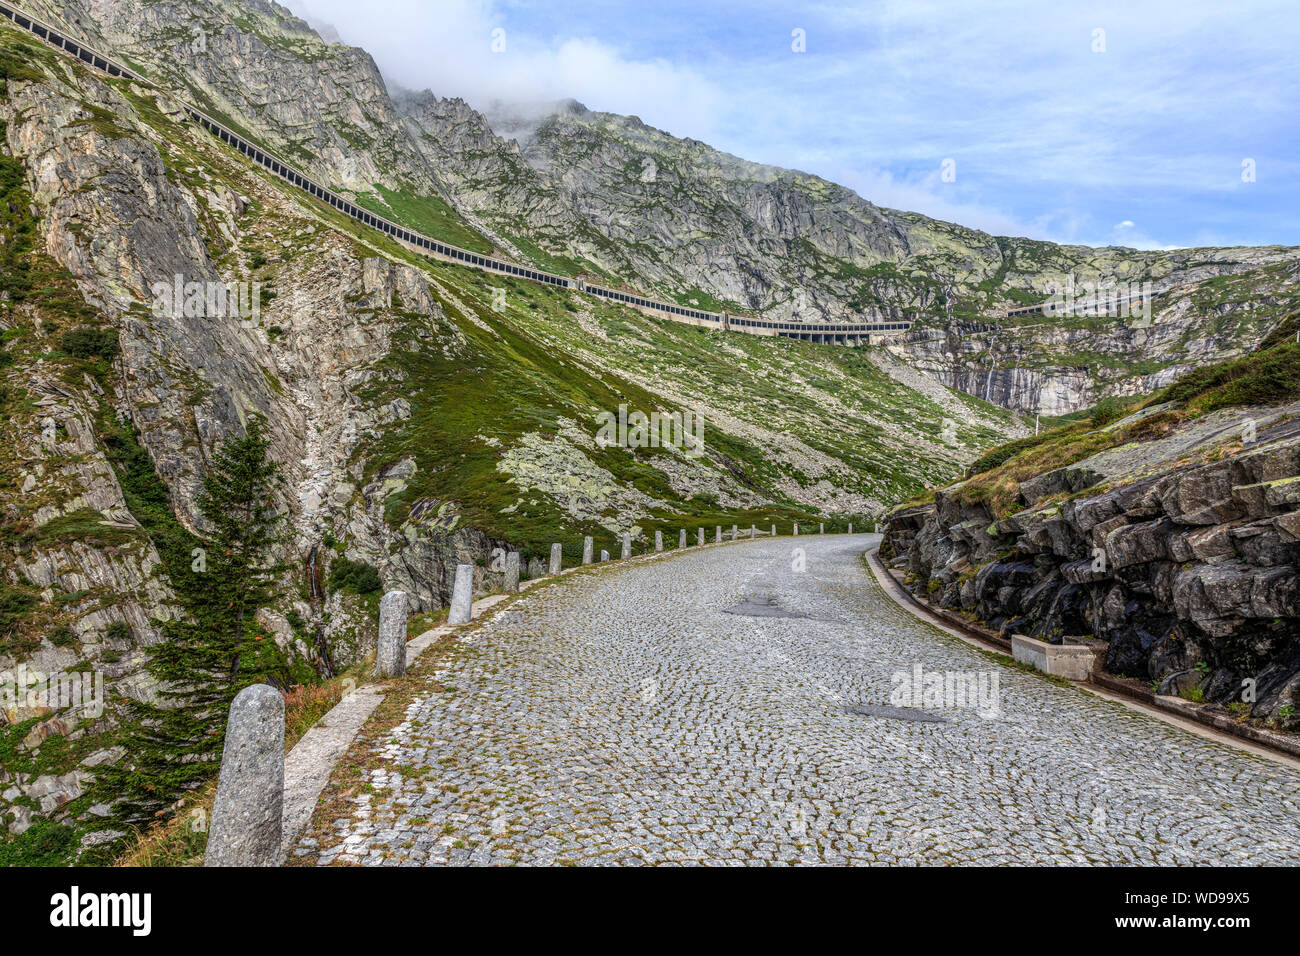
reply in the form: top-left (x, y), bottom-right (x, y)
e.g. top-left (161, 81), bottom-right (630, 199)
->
top-left (345, 238), bottom-right (1011, 561)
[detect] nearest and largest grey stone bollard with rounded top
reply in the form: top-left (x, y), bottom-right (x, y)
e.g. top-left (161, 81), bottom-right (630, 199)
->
top-left (203, 681), bottom-right (283, 866)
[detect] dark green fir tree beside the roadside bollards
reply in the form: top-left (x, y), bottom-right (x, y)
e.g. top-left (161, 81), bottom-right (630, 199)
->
top-left (95, 418), bottom-right (287, 826)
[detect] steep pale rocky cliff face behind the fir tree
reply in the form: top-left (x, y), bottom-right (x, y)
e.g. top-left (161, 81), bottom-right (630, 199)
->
top-left (0, 31), bottom-right (477, 835)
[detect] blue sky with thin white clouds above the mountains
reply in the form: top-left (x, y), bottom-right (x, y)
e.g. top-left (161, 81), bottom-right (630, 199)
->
top-left (287, 0), bottom-right (1300, 248)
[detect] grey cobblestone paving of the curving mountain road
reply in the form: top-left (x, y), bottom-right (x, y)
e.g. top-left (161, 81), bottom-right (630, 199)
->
top-left (299, 536), bottom-right (1300, 865)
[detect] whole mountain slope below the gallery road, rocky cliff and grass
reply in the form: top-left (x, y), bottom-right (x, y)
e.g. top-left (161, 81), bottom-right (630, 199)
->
top-left (0, 9), bottom-right (1023, 858)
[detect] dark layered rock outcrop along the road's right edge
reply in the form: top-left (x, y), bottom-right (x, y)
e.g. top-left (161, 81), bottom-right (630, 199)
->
top-left (881, 402), bottom-right (1300, 730)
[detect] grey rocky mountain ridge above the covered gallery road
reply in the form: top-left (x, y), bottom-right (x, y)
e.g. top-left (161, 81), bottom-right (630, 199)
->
top-left (17, 0), bottom-right (1300, 415)
